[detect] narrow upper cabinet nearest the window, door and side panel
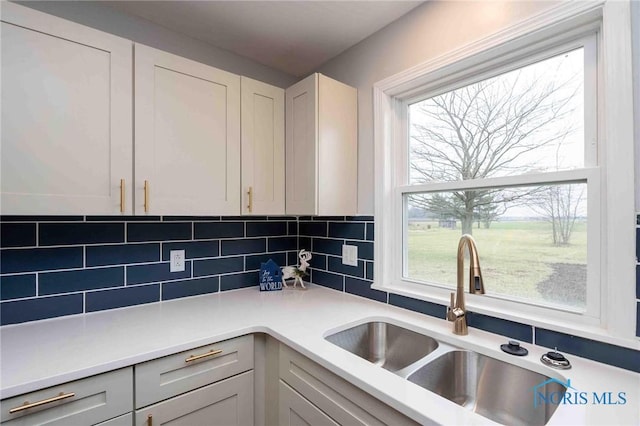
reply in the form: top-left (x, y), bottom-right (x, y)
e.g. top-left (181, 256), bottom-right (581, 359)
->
top-left (286, 74), bottom-right (358, 216)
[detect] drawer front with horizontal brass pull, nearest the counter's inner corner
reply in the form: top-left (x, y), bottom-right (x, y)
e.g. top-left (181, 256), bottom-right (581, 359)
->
top-left (135, 335), bottom-right (253, 408)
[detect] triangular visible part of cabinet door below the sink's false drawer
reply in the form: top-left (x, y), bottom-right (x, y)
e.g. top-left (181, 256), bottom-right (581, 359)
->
top-left (278, 380), bottom-right (338, 426)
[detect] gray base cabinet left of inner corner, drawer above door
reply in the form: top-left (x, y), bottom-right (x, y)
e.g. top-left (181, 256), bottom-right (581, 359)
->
top-left (135, 335), bottom-right (254, 426)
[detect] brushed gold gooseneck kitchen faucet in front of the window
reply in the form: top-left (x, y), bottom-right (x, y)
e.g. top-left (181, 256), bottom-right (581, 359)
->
top-left (447, 234), bottom-right (484, 336)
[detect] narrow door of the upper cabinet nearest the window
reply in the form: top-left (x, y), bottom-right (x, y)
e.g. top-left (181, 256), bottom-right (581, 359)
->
top-left (286, 74), bottom-right (318, 215)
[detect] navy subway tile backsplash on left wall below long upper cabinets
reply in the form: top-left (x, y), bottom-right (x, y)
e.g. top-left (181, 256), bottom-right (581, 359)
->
top-left (0, 216), bottom-right (298, 325)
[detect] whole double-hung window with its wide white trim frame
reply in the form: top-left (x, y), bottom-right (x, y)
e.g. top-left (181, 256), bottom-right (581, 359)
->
top-left (374, 2), bottom-right (636, 345)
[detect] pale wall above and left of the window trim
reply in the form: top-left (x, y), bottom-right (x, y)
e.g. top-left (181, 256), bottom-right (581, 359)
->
top-left (318, 1), bottom-right (568, 215)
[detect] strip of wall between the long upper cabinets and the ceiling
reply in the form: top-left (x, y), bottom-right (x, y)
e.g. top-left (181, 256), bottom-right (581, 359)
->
top-left (16, 1), bottom-right (299, 88)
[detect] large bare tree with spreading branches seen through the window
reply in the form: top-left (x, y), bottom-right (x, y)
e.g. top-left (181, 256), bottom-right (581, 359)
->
top-left (410, 57), bottom-right (580, 234)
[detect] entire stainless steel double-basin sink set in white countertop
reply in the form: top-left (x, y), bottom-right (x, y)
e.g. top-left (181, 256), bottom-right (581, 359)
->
top-left (326, 322), bottom-right (566, 425)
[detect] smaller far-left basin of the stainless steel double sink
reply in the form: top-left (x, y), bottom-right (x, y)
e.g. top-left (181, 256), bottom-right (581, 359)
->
top-left (326, 322), bottom-right (438, 372)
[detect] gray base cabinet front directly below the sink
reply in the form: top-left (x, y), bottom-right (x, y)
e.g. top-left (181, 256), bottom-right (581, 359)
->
top-left (278, 345), bottom-right (417, 426)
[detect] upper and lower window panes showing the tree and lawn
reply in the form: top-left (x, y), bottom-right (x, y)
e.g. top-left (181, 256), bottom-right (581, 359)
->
top-left (401, 44), bottom-right (599, 316)
